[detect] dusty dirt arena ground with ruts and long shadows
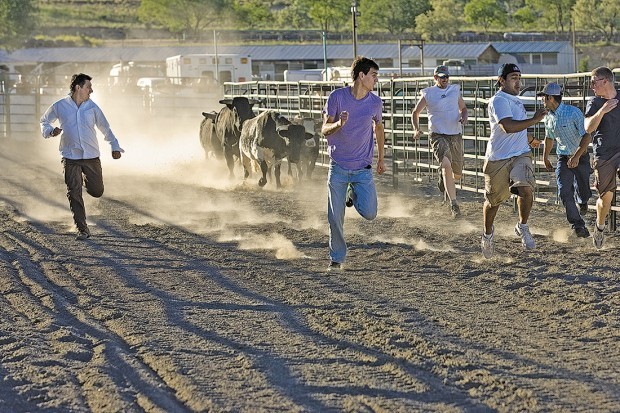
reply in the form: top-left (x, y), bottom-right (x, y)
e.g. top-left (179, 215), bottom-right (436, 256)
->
top-left (0, 106), bottom-right (620, 412)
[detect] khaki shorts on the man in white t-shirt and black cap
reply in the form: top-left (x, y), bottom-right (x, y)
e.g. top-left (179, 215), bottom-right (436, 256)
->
top-left (482, 152), bottom-right (536, 206)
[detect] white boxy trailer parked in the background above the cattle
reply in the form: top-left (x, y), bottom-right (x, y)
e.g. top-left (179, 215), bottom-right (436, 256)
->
top-left (166, 54), bottom-right (252, 85)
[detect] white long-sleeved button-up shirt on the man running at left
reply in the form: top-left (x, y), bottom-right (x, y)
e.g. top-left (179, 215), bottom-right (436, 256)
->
top-left (41, 96), bottom-right (124, 159)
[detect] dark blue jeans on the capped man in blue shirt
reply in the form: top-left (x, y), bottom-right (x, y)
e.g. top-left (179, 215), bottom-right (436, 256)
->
top-left (555, 153), bottom-right (592, 229)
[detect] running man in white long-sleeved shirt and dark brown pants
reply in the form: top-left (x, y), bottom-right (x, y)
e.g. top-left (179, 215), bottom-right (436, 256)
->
top-left (41, 73), bottom-right (124, 240)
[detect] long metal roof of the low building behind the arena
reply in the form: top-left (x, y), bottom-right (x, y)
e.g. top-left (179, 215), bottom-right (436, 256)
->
top-left (0, 42), bottom-right (569, 64)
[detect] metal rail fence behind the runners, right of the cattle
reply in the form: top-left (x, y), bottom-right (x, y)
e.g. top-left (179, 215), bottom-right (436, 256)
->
top-left (224, 69), bottom-right (620, 231)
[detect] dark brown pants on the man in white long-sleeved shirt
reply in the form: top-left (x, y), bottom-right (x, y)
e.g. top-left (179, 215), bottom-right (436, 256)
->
top-left (62, 158), bottom-right (103, 231)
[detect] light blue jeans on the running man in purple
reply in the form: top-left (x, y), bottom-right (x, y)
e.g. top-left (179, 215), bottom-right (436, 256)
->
top-left (327, 162), bottom-right (377, 263)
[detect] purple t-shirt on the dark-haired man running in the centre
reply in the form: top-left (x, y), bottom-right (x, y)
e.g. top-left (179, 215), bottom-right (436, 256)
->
top-left (323, 86), bottom-right (383, 170)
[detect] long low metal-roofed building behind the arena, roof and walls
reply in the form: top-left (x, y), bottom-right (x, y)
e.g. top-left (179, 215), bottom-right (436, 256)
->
top-left (0, 42), bottom-right (575, 80)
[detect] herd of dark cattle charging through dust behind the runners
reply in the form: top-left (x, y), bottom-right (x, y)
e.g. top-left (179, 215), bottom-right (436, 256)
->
top-left (200, 97), bottom-right (321, 188)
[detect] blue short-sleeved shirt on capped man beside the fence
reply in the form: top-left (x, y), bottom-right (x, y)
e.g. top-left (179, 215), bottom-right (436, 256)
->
top-left (545, 103), bottom-right (586, 156)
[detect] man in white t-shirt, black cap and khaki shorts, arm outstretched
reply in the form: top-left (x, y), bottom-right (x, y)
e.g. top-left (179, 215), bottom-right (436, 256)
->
top-left (481, 63), bottom-right (547, 258)
